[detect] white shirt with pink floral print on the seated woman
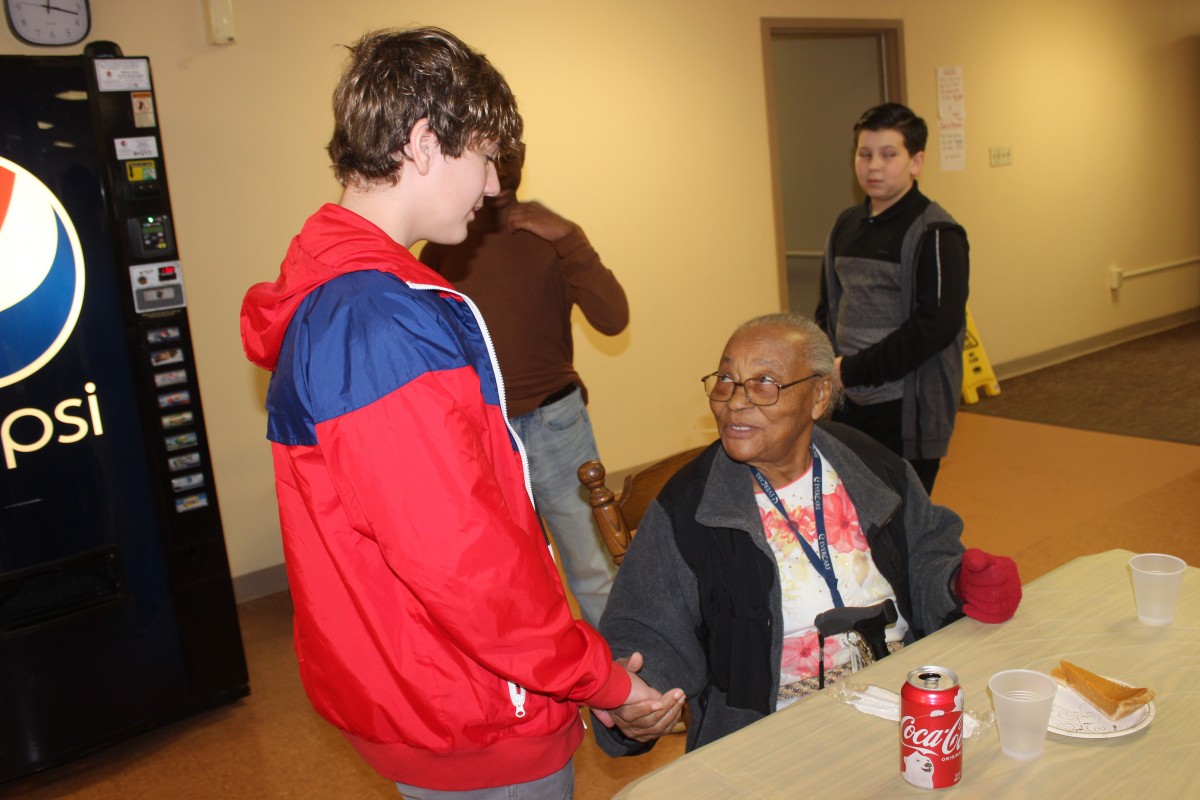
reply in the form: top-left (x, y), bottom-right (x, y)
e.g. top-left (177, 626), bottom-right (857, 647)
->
top-left (755, 443), bottom-right (908, 705)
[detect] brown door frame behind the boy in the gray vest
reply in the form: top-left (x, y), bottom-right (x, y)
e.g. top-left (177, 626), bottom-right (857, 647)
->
top-left (762, 17), bottom-right (907, 311)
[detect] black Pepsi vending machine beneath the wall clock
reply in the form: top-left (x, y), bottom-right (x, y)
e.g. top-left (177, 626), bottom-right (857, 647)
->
top-left (0, 43), bottom-right (250, 782)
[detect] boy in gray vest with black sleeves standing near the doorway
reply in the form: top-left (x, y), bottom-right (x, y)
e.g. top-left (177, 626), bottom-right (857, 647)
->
top-left (815, 103), bottom-right (970, 492)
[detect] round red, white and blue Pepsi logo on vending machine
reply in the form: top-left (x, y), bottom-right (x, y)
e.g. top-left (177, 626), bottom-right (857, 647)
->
top-left (0, 158), bottom-right (84, 387)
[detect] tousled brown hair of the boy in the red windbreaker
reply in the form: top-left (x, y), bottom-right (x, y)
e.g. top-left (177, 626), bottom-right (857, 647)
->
top-left (328, 28), bottom-right (523, 186)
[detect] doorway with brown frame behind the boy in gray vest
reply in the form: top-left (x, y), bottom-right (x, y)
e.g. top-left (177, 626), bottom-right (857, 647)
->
top-left (762, 19), bottom-right (905, 315)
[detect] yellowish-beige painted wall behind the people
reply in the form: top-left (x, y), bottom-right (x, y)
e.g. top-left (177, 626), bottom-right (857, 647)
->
top-left (0, 0), bottom-right (1200, 585)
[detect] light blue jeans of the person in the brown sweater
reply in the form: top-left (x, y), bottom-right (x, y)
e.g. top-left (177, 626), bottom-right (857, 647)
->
top-left (511, 389), bottom-right (617, 626)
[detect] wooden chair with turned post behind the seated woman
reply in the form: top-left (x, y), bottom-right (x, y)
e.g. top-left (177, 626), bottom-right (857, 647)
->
top-left (578, 447), bottom-right (704, 566)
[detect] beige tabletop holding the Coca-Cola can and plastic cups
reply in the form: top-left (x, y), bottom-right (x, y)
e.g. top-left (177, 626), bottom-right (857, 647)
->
top-left (617, 551), bottom-right (1200, 800)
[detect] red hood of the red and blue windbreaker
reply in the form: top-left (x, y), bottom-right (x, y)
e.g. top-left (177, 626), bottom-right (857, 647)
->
top-left (241, 204), bottom-right (452, 371)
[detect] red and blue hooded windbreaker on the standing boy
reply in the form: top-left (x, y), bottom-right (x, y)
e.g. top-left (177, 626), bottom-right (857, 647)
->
top-left (241, 205), bottom-right (629, 790)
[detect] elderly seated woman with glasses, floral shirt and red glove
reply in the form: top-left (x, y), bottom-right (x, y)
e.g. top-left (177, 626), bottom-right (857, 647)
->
top-left (594, 314), bottom-right (1021, 756)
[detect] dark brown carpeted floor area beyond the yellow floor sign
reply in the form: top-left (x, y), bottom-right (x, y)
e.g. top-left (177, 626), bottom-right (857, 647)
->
top-left (961, 321), bottom-right (1200, 445)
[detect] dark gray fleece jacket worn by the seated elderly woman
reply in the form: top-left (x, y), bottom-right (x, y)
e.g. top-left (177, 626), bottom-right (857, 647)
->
top-left (594, 422), bottom-right (964, 756)
